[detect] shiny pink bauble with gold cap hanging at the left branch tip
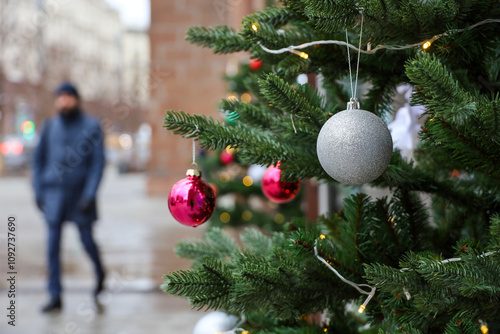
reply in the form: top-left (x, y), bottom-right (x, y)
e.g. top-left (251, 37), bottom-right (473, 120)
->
top-left (168, 169), bottom-right (215, 227)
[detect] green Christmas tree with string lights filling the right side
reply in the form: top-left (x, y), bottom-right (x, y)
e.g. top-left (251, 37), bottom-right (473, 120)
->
top-left (163, 0), bottom-right (500, 333)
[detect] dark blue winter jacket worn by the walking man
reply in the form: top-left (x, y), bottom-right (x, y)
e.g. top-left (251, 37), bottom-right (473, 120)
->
top-left (33, 110), bottom-right (105, 224)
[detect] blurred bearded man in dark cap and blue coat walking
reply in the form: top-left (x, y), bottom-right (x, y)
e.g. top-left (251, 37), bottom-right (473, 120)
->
top-left (33, 83), bottom-right (104, 312)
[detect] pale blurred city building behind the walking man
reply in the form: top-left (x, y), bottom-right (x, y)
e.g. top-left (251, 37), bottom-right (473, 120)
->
top-left (0, 0), bottom-right (150, 173)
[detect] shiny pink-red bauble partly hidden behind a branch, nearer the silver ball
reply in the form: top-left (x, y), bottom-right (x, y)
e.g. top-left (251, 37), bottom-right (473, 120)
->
top-left (262, 162), bottom-right (300, 203)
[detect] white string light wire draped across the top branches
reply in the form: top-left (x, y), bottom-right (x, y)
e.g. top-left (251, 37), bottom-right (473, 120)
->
top-left (257, 19), bottom-right (500, 54)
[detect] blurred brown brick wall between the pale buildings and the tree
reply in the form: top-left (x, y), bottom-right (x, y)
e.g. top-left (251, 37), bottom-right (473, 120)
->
top-left (148, 0), bottom-right (264, 196)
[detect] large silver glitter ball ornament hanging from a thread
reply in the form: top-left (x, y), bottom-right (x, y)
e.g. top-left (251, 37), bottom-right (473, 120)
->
top-left (317, 102), bottom-right (392, 185)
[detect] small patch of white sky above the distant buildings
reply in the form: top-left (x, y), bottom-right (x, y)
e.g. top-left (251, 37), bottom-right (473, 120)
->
top-left (106, 0), bottom-right (150, 28)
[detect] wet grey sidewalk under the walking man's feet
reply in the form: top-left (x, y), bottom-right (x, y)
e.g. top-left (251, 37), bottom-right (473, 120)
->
top-left (0, 167), bottom-right (206, 334)
